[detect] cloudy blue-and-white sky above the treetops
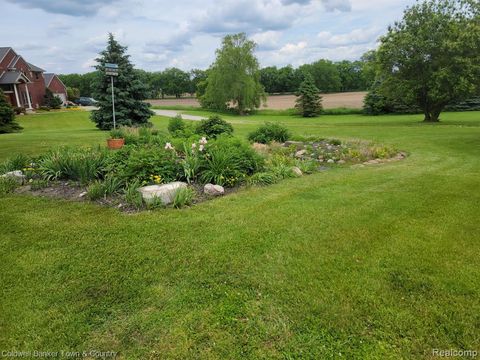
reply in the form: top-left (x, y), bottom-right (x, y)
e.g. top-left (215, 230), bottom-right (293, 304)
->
top-left (0, 0), bottom-right (414, 73)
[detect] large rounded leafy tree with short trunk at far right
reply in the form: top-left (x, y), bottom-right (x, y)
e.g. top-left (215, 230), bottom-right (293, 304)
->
top-left (377, 0), bottom-right (480, 122)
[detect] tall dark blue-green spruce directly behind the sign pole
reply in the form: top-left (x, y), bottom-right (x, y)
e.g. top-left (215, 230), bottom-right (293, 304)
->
top-left (91, 34), bottom-right (153, 130)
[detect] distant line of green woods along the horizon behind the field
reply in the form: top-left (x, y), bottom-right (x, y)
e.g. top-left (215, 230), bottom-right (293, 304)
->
top-left (59, 52), bottom-right (375, 99)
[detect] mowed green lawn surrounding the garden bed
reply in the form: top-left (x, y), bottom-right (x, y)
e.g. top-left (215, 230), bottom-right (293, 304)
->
top-left (0, 112), bottom-right (480, 359)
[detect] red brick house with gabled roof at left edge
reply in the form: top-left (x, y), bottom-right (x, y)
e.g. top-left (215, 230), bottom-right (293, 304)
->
top-left (0, 47), bottom-right (67, 110)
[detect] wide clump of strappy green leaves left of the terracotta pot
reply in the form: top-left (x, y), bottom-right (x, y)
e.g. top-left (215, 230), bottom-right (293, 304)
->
top-left (38, 147), bottom-right (107, 184)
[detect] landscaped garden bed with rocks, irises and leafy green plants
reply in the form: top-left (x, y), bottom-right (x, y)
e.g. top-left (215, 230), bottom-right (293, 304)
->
top-left (0, 117), bottom-right (405, 211)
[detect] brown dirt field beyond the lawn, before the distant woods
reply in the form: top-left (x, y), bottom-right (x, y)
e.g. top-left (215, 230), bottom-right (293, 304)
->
top-left (147, 92), bottom-right (367, 110)
